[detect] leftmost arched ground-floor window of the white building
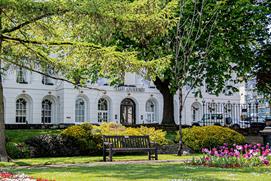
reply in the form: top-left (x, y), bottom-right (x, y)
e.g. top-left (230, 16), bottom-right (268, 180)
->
top-left (16, 98), bottom-right (27, 123)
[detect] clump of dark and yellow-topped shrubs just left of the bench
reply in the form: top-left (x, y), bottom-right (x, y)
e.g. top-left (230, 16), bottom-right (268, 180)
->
top-left (25, 124), bottom-right (102, 157)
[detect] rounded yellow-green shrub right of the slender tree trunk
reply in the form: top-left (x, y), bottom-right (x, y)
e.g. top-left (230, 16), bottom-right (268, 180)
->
top-left (176, 126), bottom-right (245, 152)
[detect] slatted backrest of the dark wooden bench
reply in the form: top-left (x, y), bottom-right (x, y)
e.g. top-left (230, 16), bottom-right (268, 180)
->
top-left (103, 135), bottom-right (150, 148)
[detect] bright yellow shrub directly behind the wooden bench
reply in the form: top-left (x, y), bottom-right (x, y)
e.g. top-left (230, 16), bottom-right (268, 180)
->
top-left (95, 122), bottom-right (168, 145)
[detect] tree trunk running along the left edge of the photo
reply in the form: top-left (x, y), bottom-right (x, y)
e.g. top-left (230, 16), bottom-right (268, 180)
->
top-left (0, 9), bottom-right (8, 162)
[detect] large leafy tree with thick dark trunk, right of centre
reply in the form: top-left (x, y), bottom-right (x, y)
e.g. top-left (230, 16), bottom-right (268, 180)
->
top-left (77, 0), bottom-right (269, 127)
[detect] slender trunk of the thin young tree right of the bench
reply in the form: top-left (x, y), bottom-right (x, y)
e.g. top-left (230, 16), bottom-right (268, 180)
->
top-left (177, 89), bottom-right (184, 156)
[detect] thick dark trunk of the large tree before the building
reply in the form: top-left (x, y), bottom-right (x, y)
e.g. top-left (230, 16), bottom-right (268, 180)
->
top-left (154, 77), bottom-right (176, 125)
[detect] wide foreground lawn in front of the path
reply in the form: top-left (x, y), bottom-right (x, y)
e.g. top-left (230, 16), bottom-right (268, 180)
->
top-left (3, 163), bottom-right (271, 181)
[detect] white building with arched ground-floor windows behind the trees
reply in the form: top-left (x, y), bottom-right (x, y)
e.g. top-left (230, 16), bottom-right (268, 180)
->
top-left (3, 69), bottom-right (240, 125)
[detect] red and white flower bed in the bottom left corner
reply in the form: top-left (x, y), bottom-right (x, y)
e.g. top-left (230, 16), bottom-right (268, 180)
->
top-left (0, 171), bottom-right (52, 181)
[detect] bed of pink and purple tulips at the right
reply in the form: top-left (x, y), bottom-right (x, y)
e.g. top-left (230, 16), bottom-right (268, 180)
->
top-left (192, 144), bottom-right (271, 168)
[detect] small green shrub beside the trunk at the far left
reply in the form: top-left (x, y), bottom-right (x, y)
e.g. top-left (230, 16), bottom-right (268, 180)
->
top-left (6, 142), bottom-right (30, 159)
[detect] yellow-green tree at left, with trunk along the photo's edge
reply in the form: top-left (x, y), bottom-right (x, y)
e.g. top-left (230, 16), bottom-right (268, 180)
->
top-left (0, 0), bottom-right (134, 161)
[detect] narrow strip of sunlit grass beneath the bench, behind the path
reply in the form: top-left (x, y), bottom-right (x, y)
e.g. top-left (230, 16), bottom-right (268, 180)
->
top-left (0, 154), bottom-right (198, 167)
